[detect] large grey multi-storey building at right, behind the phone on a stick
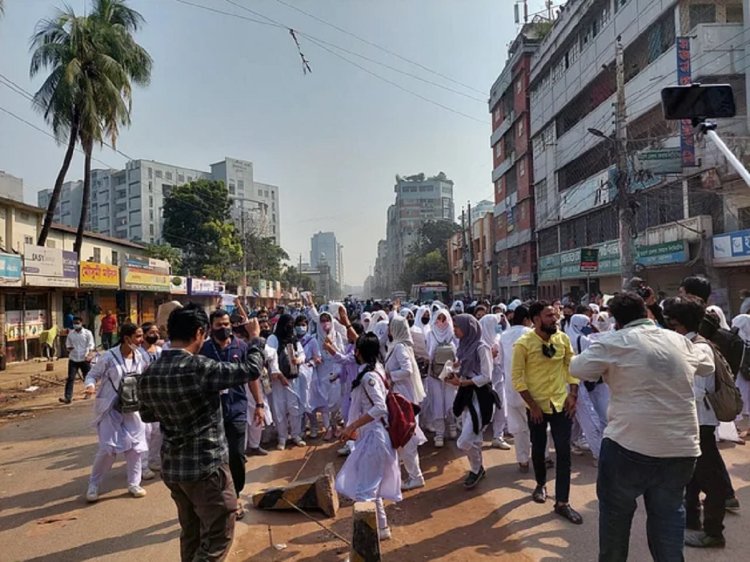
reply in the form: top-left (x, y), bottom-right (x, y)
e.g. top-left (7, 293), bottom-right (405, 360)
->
top-left (529, 0), bottom-right (750, 308)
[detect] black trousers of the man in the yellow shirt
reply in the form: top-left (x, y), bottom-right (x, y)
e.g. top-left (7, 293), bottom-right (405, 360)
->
top-left (527, 404), bottom-right (573, 504)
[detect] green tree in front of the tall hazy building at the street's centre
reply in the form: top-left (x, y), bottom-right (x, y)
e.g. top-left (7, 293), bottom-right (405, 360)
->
top-left (400, 221), bottom-right (461, 292)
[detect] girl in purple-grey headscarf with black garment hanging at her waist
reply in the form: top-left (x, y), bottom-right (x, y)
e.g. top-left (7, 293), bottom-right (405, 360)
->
top-left (447, 314), bottom-right (497, 489)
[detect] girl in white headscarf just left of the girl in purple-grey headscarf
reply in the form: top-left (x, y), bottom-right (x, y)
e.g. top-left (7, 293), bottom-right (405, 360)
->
top-left (425, 308), bottom-right (458, 448)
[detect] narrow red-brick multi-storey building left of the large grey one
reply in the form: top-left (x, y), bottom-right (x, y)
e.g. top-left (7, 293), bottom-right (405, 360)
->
top-left (489, 22), bottom-right (549, 299)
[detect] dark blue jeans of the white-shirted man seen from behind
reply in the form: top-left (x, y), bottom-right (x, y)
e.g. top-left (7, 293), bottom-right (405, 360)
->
top-left (596, 438), bottom-right (695, 562)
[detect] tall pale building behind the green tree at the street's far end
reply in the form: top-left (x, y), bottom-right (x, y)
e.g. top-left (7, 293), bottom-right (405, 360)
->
top-left (384, 172), bottom-right (456, 292)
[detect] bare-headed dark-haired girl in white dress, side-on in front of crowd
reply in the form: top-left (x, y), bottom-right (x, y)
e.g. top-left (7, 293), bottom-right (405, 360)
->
top-left (336, 333), bottom-right (401, 540)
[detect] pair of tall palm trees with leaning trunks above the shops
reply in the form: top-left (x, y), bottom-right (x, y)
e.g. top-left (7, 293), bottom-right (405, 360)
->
top-left (31, 0), bottom-right (152, 249)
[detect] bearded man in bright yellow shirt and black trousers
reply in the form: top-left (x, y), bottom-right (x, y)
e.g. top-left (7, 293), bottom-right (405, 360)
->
top-left (512, 301), bottom-right (583, 525)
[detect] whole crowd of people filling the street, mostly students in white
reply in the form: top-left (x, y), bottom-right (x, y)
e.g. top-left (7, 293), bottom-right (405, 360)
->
top-left (66, 277), bottom-right (750, 561)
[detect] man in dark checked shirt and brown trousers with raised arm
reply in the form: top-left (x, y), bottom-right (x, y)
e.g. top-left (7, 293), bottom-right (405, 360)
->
top-left (138, 304), bottom-right (264, 561)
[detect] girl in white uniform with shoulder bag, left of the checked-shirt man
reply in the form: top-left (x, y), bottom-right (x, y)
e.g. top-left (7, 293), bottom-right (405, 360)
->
top-left (84, 323), bottom-right (148, 502)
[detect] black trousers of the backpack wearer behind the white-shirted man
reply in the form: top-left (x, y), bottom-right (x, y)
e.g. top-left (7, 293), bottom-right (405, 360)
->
top-left (685, 425), bottom-right (731, 537)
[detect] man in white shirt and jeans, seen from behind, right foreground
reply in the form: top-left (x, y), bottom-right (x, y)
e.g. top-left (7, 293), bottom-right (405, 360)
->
top-left (570, 292), bottom-right (714, 562)
